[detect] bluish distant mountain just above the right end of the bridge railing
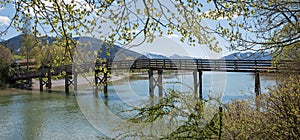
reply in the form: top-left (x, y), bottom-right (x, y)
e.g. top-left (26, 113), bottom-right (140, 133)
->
top-left (223, 52), bottom-right (272, 60)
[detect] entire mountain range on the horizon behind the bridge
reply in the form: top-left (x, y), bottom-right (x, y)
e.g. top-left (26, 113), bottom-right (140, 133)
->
top-left (0, 35), bottom-right (272, 60)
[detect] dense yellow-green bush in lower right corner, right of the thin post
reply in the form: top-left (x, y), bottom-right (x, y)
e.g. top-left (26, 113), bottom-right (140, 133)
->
top-left (223, 75), bottom-right (300, 139)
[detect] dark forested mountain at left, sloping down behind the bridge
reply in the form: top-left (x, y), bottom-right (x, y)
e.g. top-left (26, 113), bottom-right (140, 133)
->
top-left (0, 35), bottom-right (143, 60)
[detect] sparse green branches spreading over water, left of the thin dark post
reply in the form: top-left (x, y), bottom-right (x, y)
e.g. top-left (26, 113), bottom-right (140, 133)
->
top-left (118, 90), bottom-right (221, 139)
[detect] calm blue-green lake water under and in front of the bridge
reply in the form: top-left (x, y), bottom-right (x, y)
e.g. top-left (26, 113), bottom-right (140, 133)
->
top-left (0, 72), bottom-right (276, 140)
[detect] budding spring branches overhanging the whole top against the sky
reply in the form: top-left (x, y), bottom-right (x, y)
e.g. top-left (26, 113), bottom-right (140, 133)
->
top-left (0, 0), bottom-right (300, 59)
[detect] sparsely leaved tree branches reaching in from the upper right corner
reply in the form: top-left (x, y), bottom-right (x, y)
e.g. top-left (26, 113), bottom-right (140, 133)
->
top-left (209, 0), bottom-right (300, 50)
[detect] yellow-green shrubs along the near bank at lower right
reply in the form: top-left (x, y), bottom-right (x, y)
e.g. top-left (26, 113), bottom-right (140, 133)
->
top-left (116, 71), bottom-right (300, 140)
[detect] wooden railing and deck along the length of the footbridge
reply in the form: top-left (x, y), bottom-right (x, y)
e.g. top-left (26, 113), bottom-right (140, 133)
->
top-left (11, 59), bottom-right (286, 80)
